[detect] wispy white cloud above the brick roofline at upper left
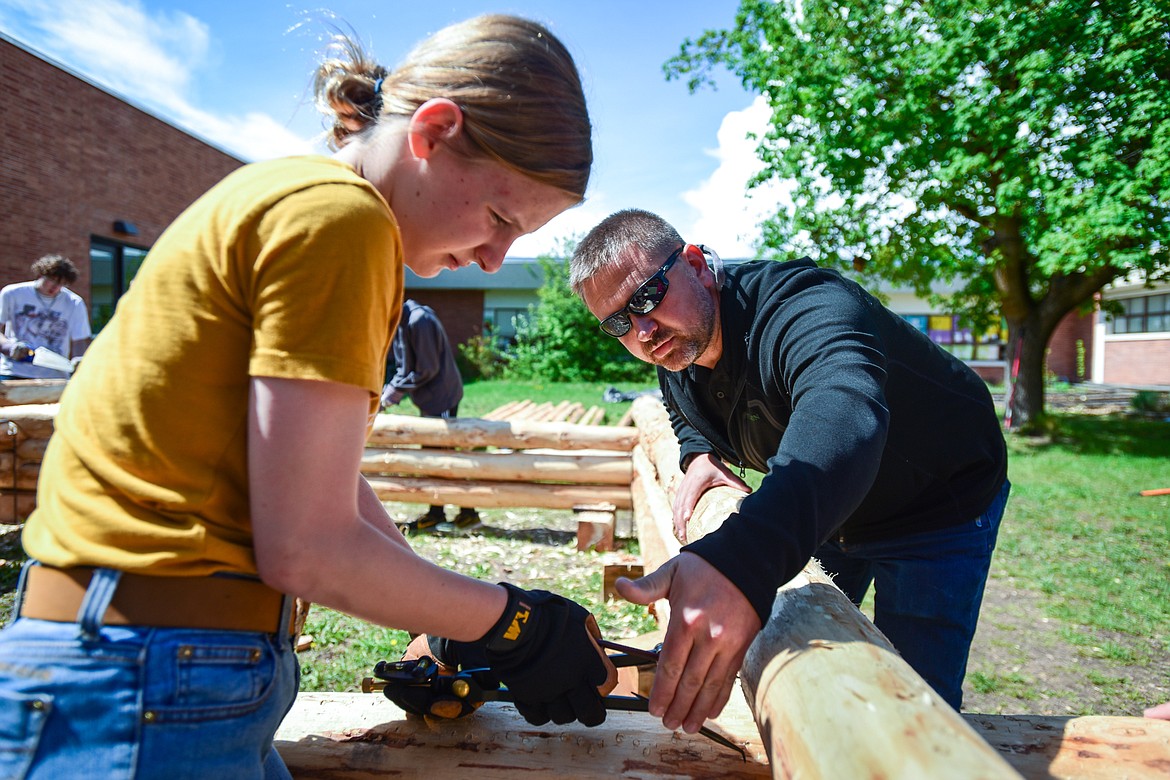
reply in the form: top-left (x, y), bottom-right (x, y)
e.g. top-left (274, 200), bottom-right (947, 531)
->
top-left (4, 0), bottom-right (314, 160)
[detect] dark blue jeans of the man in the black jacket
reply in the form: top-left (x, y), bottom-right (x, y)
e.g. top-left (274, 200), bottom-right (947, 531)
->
top-left (815, 481), bottom-right (1011, 710)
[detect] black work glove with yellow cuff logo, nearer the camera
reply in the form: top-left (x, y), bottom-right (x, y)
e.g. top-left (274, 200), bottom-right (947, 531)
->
top-left (475, 582), bottom-right (608, 726)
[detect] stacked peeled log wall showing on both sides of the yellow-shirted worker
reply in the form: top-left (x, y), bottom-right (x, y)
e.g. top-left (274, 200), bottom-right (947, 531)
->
top-left (0, 406), bottom-right (638, 524)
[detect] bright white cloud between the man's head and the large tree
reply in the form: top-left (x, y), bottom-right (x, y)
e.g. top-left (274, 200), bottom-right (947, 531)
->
top-left (676, 97), bottom-right (792, 257)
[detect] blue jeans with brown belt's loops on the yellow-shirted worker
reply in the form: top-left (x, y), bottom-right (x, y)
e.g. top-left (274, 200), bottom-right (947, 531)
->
top-left (0, 570), bottom-right (298, 780)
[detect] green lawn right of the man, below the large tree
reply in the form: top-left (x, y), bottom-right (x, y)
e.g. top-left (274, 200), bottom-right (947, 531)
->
top-left (996, 414), bottom-right (1170, 655)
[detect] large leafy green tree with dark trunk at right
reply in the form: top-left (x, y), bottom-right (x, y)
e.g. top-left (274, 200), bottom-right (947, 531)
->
top-left (666, 0), bottom-right (1170, 426)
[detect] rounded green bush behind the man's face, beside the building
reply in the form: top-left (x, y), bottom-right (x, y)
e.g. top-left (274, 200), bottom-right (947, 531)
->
top-left (505, 250), bottom-right (654, 384)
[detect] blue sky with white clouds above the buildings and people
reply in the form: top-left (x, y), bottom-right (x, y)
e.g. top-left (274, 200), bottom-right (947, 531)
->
top-left (0, 0), bottom-right (780, 257)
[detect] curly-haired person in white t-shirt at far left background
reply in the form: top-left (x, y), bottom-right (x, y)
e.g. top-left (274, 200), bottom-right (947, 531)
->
top-left (0, 255), bottom-right (92, 379)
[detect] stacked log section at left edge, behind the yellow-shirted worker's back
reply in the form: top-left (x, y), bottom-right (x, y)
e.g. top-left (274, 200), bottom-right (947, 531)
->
top-left (0, 406), bottom-right (57, 525)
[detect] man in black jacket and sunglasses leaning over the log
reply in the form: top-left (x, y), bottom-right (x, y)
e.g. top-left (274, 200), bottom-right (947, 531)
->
top-left (571, 209), bottom-right (1009, 731)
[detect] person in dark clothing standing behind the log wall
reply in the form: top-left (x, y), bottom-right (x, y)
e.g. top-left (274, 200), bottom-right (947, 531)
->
top-left (381, 298), bottom-right (482, 533)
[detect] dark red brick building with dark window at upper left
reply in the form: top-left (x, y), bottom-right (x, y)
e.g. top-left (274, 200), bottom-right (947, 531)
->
top-left (0, 33), bottom-right (243, 326)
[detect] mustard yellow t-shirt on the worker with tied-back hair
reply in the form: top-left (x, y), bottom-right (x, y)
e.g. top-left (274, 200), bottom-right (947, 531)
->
top-left (23, 157), bottom-right (402, 575)
